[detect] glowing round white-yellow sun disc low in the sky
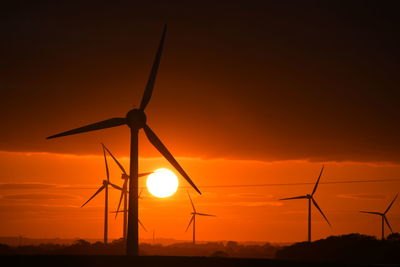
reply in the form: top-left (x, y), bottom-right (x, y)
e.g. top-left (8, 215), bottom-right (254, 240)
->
top-left (146, 168), bottom-right (179, 198)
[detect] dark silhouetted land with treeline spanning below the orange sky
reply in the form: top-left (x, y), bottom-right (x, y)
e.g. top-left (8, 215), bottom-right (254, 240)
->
top-left (0, 233), bottom-right (400, 267)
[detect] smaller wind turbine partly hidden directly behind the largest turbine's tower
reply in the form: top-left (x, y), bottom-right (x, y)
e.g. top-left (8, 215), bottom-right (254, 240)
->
top-left (101, 143), bottom-right (153, 239)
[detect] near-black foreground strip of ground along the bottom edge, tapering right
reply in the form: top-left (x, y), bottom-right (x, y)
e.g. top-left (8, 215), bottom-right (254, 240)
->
top-left (0, 255), bottom-right (374, 267)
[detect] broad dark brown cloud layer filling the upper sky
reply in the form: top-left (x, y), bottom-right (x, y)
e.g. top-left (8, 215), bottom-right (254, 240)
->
top-left (0, 1), bottom-right (400, 162)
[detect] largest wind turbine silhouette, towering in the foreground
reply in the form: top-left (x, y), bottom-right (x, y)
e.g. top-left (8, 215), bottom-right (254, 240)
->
top-left (47, 25), bottom-right (201, 256)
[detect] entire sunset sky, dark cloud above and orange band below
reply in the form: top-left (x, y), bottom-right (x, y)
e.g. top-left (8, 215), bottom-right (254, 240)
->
top-left (0, 1), bottom-right (400, 241)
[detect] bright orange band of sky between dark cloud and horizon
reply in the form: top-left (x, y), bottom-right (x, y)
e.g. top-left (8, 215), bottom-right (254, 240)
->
top-left (0, 151), bottom-right (400, 242)
